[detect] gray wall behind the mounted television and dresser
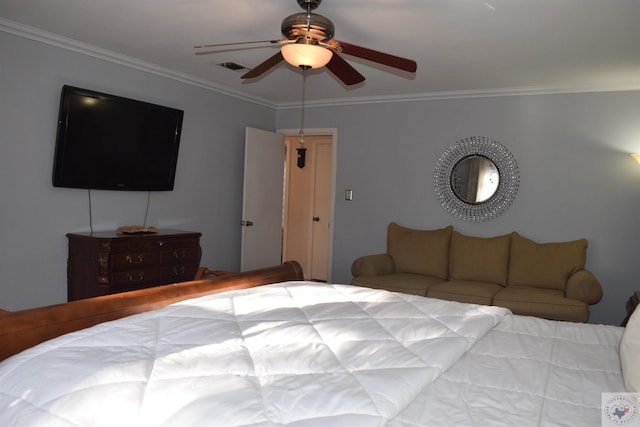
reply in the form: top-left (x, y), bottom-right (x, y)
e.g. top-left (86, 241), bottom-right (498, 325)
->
top-left (0, 32), bottom-right (275, 310)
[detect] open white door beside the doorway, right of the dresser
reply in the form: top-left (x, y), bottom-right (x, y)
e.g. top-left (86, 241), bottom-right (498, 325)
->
top-left (240, 127), bottom-right (285, 271)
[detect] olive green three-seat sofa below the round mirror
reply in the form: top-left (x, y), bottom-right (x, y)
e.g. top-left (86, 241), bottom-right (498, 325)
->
top-left (351, 223), bottom-right (602, 322)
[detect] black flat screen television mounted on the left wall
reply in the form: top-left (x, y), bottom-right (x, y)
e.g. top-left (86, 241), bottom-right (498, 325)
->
top-left (53, 85), bottom-right (184, 191)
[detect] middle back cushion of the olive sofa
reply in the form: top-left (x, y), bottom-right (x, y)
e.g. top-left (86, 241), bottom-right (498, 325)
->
top-left (449, 231), bottom-right (511, 286)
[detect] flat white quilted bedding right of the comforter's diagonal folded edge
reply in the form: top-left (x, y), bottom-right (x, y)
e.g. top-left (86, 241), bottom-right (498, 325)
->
top-left (388, 316), bottom-right (626, 427)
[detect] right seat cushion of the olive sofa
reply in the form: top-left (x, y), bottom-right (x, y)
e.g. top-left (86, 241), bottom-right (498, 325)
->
top-left (493, 285), bottom-right (589, 322)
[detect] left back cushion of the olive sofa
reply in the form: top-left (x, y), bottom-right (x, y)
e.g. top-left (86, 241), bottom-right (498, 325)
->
top-left (387, 222), bottom-right (453, 279)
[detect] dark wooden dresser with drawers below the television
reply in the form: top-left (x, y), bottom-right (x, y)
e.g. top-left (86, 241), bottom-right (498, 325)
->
top-left (67, 230), bottom-right (202, 301)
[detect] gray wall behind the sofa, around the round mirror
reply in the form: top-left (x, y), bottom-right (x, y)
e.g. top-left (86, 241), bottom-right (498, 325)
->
top-left (277, 92), bottom-right (640, 324)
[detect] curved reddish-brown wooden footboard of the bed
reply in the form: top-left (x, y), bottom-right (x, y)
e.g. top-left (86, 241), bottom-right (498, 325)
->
top-left (0, 261), bottom-right (304, 361)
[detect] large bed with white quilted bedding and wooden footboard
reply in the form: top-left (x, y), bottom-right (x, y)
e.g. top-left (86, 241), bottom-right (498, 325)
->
top-left (0, 262), bottom-right (640, 427)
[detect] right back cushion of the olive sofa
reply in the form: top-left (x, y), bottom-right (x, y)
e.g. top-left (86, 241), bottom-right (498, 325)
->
top-left (509, 232), bottom-right (588, 292)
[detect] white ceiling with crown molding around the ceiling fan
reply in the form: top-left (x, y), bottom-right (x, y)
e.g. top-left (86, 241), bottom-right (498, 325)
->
top-left (0, 0), bottom-right (640, 107)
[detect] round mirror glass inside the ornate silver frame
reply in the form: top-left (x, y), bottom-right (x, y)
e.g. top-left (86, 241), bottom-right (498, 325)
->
top-left (451, 154), bottom-right (500, 204)
